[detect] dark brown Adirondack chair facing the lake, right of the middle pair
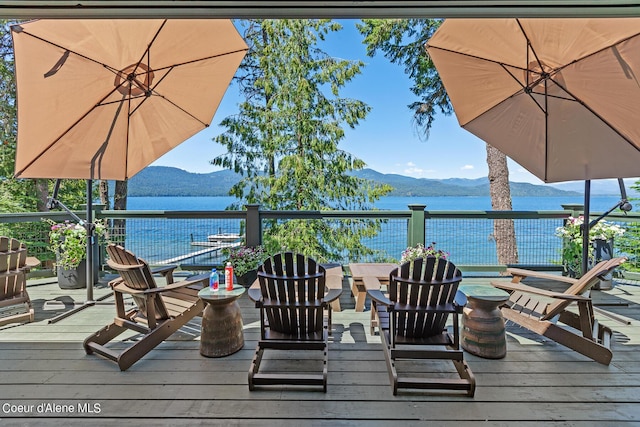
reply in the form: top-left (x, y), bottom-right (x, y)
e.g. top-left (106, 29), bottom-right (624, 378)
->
top-left (367, 257), bottom-right (475, 396)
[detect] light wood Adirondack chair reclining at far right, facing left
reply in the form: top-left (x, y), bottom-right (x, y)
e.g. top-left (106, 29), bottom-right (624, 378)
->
top-left (491, 257), bottom-right (626, 365)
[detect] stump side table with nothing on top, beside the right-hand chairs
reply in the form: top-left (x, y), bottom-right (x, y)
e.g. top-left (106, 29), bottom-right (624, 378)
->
top-left (458, 285), bottom-right (509, 359)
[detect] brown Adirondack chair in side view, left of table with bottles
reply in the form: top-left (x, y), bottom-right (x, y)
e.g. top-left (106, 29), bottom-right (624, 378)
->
top-left (84, 244), bottom-right (207, 371)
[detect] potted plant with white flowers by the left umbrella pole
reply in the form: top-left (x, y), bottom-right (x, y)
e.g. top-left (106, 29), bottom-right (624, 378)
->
top-left (46, 219), bottom-right (106, 289)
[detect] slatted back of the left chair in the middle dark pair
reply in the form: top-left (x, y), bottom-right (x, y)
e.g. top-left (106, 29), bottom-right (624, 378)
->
top-left (258, 252), bottom-right (326, 336)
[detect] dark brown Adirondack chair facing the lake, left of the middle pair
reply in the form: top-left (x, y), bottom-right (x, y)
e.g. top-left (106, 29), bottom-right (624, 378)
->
top-left (249, 252), bottom-right (342, 392)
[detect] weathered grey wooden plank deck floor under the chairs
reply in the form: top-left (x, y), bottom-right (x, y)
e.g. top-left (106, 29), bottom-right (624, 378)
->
top-left (0, 272), bottom-right (640, 426)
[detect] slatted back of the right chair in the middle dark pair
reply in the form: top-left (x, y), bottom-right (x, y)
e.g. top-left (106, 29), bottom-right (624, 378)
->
top-left (389, 256), bottom-right (462, 338)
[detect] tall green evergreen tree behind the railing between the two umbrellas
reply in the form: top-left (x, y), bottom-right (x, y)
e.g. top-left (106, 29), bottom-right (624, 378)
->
top-left (213, 20), bottom-right (390, 260)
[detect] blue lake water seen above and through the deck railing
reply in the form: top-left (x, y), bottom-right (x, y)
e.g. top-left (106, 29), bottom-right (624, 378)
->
top-left (117, 196), bottom-right (619, 264)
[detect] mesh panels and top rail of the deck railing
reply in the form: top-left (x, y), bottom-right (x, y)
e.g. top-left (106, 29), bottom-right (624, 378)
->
top-left (0, 210), bottom-right (640, 271)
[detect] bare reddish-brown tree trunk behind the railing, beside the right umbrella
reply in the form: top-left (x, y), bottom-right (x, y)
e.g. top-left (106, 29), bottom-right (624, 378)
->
top-left (487, 144), bottom-right (518, 264)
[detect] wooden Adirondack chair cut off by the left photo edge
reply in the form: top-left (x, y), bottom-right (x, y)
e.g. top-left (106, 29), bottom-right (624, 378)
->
top-left (0, 236), bottom-right (40, 326)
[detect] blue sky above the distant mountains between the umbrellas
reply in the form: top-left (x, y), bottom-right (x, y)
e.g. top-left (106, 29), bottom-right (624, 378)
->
top-left (153, 20), bottom-right (542, 184)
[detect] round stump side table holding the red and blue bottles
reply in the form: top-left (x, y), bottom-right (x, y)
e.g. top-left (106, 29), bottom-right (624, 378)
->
top-left (198, 285), bottom-right (246, 357)
